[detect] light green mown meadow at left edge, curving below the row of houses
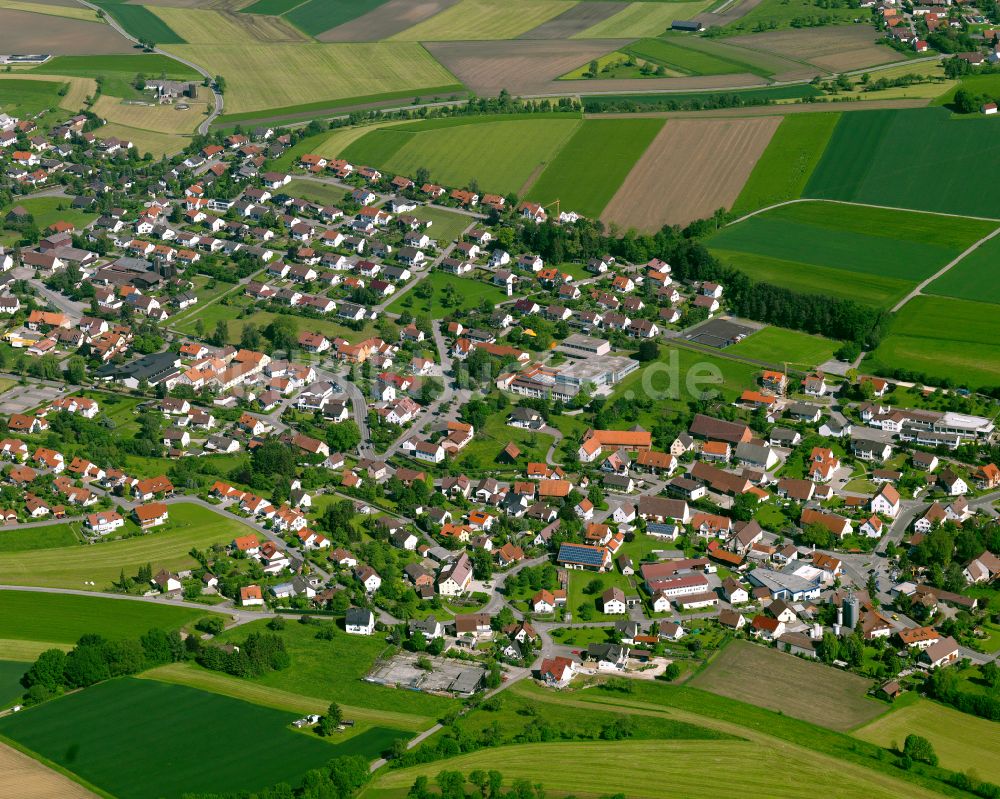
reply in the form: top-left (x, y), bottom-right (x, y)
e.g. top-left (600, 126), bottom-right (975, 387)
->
top-left (0, 503), bottom-right (247, 591)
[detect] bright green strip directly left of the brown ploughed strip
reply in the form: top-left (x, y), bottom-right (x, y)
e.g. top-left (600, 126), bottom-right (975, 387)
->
top-left (527, 119), bottom-right (663, 218)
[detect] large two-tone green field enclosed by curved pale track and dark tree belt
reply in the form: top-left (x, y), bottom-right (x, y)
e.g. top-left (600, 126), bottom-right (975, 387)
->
top-left (707, 202), bottom-right (993, 305)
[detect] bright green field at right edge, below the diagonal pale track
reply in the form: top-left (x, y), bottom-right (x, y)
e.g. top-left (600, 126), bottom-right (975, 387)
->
top-left (866, 296), bottom-right (1000, 388)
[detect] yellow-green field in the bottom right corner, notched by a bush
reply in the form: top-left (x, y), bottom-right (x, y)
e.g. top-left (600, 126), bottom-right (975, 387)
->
top-left (854, 697), bottom-right (1000, 785)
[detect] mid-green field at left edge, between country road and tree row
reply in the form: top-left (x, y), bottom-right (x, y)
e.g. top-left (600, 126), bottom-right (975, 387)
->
top-left (0, 591), bottom-right (218, 644)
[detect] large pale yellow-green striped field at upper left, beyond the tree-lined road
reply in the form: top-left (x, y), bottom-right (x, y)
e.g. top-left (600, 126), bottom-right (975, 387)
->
top-left (170, 42), bottom-right (455, 114)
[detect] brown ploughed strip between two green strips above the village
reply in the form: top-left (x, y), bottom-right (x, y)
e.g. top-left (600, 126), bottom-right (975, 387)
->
top-left (601, 117), bottom-right (781, 233)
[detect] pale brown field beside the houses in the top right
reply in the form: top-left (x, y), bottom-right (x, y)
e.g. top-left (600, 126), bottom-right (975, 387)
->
top-left (727, 25), bottom-right (903, 72)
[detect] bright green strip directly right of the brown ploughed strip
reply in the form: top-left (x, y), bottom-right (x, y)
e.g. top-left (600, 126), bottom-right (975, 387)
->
top-left (733, 112), bottom-right (840, 214)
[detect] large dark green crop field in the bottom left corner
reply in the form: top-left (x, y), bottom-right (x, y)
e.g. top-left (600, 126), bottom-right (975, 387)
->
top-left (0, 678), bottom-right (398, 799)
